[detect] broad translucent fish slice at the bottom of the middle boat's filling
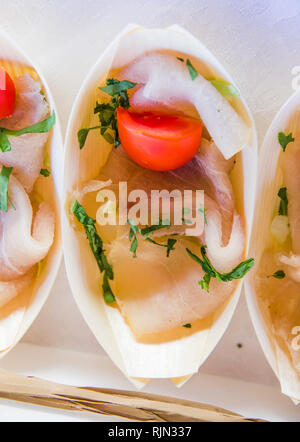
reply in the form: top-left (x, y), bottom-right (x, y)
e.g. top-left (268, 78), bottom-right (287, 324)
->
top-left (109, 238), bottom-right (236, 335)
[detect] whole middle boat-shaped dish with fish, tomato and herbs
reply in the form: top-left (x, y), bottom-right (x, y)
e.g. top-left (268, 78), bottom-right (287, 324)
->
top-left (63, 25), bottom-right (257, 386)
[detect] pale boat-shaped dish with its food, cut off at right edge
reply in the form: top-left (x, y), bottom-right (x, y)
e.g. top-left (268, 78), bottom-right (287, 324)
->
top-left (245, 91), bottom-right (300, 403)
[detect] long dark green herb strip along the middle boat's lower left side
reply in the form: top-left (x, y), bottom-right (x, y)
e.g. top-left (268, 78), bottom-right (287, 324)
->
top-left (72, 201), bottom-right (116, 304)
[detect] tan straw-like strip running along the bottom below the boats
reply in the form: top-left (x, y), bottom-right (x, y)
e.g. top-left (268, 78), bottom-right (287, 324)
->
top-left (0, 370), bottom-right (262, 422)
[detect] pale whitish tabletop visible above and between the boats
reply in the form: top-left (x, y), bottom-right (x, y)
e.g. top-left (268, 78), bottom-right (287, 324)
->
top-left (0, 0), bottom-right (300, 422)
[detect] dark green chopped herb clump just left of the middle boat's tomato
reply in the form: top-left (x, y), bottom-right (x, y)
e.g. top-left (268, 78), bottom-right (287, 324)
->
top-left (77, 78), bottom-right (136, 149)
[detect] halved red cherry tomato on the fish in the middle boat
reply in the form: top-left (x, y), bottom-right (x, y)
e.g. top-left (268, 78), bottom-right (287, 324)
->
top-left (117, 107), bottom-right (202, 171)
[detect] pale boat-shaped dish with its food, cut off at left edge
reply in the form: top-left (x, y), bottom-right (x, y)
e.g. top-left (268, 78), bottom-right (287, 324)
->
top-left (0, 32), bottom-right (62, 357)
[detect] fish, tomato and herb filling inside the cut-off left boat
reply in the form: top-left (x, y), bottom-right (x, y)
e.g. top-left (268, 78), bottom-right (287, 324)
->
top-left (0, 66), bottom-right (55, 307)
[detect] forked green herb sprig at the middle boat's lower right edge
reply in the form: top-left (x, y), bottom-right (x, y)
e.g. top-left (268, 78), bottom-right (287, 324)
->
top-left (186, 246), bottom-right (254, 292)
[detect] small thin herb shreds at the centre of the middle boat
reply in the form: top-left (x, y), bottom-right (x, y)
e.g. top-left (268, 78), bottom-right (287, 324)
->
top-left (127, 220), bottom-right (177, 258)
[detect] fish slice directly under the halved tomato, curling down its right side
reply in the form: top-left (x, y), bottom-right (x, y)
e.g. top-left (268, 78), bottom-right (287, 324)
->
top-left (97, 139), bottom-right (245, 273)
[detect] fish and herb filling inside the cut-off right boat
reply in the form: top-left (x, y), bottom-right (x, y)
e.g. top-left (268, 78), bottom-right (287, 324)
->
top-left (255, 106), bottom-right (300, 401)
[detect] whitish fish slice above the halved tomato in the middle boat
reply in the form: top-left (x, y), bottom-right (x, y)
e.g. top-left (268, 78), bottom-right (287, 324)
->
top-left (120, 53), bottom-right (251, 159)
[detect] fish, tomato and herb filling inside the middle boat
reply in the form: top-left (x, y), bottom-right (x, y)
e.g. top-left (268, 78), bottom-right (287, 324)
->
top-left (72, 53), bottom-right (253, 338)
